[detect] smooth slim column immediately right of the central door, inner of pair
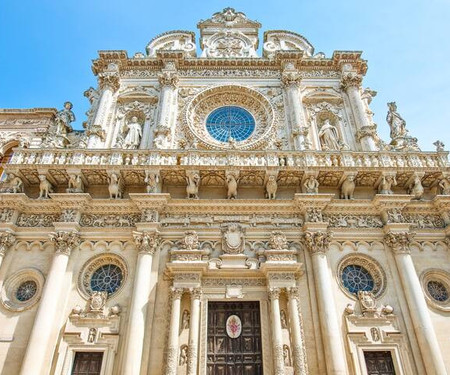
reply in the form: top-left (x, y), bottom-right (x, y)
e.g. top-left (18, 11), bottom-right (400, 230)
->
top-left (268, 288), bottom-right (285, 375)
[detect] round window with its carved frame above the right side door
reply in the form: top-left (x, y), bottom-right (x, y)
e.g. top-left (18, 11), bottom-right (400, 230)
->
top-left (337, 254), bottom-right (386, 298)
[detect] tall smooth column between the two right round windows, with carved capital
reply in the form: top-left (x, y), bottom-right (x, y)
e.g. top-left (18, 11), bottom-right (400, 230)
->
top-left (384, 231), bottom-right (447, 375)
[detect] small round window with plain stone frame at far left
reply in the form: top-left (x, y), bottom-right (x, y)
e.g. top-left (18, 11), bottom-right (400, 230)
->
top-left (1, 268), bottom-right (44, 311)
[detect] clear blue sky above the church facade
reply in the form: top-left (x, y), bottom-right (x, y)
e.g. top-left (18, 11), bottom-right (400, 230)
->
top-left (0, 0), bottom-right (450, 150)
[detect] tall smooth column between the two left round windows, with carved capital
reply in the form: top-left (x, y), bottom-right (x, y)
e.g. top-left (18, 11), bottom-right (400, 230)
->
top-left (20, 231), bottom-right (80, 375)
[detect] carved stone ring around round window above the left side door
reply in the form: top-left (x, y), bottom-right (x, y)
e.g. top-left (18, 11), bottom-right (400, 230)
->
top-left (78, 254), bottom-right (128, 299)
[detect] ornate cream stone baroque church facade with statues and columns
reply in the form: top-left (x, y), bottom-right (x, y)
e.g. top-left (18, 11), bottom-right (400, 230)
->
top-left (0, 8), bottom-right (450, 375)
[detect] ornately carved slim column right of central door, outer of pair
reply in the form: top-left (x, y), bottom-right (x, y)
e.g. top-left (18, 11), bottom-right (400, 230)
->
top-left (287, 287), bottom-right (308, 375)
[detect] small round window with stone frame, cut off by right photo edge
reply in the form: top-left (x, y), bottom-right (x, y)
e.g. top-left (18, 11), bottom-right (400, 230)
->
top-left (420, 269), bottom-right (450, 312)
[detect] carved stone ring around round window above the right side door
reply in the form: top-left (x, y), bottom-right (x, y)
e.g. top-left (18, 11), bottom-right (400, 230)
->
top-left (336, 254), bottom-right (386, 299)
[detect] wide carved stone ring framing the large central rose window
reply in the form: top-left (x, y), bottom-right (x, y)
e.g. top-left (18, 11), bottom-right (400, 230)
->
top-left (183, 85), bottom-right (278, 150)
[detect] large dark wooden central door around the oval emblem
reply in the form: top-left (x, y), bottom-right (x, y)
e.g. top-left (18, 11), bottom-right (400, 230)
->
top-left (207, 302), bottom-right (263, 375)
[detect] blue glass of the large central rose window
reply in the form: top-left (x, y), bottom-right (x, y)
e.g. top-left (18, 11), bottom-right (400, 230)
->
top-left (206, 106), bottom-right (255, 142)
